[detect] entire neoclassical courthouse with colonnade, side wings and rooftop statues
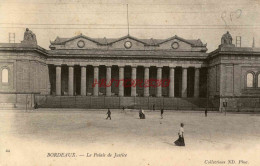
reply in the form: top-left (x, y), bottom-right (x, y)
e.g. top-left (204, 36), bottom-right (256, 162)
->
top-left (0, 29), bottom-right (260, 111)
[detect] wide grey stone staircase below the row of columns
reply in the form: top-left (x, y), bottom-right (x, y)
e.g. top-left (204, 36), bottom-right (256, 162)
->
top-left (35, 96), bottom-right (217, 110)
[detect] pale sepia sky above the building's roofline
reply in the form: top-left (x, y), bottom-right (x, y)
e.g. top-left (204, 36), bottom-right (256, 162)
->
top-left (0, 0), bottom-right (260, 52)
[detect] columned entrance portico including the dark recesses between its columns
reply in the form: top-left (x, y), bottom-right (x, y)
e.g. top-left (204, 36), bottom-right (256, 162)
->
top-left (50, 64), bottom-right (205, 98)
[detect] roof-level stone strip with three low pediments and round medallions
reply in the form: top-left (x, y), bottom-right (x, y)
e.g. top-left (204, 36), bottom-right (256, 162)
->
top-left (50, 34), bottom-right (207, 51)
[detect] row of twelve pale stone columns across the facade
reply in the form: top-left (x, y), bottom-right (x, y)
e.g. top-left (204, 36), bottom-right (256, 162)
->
top-left (55, 66), bottom-right (200, 98)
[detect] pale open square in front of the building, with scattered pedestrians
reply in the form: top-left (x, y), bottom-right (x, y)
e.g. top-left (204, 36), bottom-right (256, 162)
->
top-left (0, 109), bottom-right (260, 166)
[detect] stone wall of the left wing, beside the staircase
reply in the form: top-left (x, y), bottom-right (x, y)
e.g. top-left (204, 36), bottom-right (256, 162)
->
top-left (0, 48), bottom-right (49, 108)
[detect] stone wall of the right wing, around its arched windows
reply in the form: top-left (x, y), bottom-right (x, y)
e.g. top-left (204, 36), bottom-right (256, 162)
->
top-left (208, 47), bottom-right (260, 111)
